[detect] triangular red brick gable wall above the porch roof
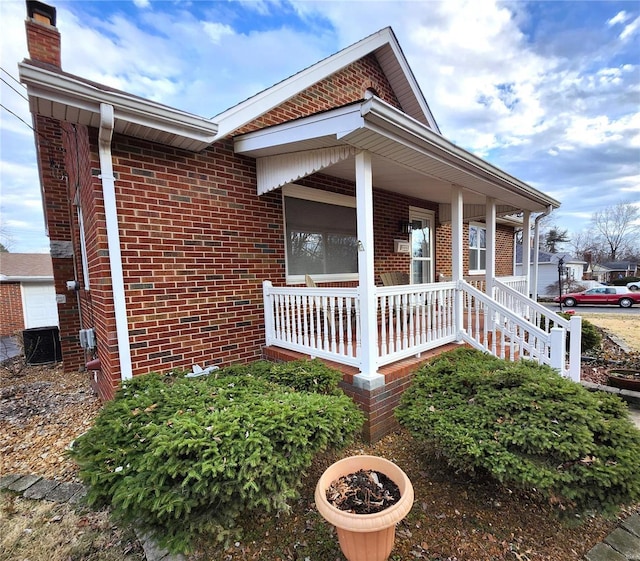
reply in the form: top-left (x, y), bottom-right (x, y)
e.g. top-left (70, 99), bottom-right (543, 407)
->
top-left (237, 55), bottom-right (402, 133)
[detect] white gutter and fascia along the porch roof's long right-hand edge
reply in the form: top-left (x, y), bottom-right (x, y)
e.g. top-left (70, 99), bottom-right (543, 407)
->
top-left (361, 98), bottom-right (560, 208)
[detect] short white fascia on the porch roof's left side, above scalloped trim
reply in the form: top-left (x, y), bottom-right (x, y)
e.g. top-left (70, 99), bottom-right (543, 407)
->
top-left (234, 104), bottom-right (364, 154)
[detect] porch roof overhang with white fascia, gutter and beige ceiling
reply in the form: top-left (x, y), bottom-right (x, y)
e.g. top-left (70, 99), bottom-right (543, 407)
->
top-left (235, 98), bottom-right (560, 214)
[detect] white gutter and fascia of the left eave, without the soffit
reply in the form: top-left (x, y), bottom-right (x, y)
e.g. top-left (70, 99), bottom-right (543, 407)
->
top-left (18, 62), bottom-right (218, 148)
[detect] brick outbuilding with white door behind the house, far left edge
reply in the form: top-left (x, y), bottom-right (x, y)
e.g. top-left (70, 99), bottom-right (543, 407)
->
top-left (0, 253), bottom-right (58, 337)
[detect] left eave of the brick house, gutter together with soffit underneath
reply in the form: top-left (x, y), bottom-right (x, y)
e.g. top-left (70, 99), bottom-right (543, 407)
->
top-left (18, 60), bottom-right (218, 151)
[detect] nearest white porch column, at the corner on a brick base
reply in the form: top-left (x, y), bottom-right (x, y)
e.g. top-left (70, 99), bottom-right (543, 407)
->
top-left (353, 151), bottom-right (384, 390)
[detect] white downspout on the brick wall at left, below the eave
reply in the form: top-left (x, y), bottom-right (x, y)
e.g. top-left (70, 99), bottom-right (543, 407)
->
top-left (98, 103), bottom-right (133, 380)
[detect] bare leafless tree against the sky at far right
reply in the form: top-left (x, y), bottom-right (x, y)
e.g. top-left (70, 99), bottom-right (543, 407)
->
top-left (591, 203), bottom-right (640, 261)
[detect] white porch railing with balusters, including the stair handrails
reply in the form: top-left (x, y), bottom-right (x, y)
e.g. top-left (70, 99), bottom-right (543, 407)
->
top-left (263, 281), bottom-right (580, 380)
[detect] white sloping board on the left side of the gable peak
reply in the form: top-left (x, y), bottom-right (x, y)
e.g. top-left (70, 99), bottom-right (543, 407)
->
top-left (212, 27), bottom-right (395, 140)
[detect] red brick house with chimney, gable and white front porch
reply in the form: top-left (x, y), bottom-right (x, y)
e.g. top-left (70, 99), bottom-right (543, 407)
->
top-left (19, 2), bottom-right (579, 439)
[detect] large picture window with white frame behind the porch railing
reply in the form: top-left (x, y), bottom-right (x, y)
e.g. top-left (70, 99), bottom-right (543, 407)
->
top-left (283, 185), bottom-right (358, 282)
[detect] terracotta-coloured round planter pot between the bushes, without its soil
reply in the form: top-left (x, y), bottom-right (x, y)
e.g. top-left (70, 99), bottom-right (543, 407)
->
top-left (315, 456), bottom-right (413, 561)
